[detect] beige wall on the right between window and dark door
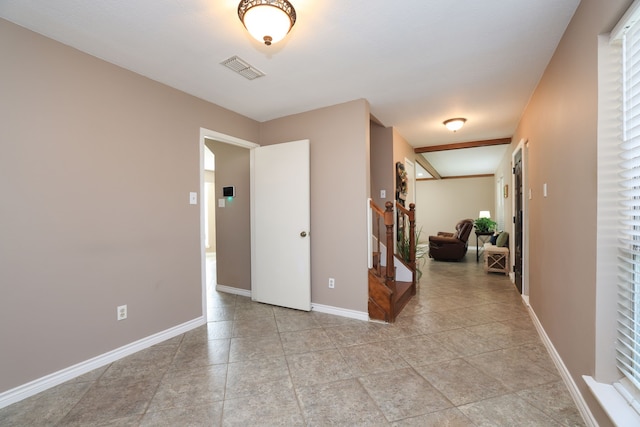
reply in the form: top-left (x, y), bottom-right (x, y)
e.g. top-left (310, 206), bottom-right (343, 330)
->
top-left (496, 0), bottom-right (631, 426)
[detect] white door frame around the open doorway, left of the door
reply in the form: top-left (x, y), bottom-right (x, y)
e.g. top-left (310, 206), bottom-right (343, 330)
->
top-left (198, 128), bottom-right (260, 320)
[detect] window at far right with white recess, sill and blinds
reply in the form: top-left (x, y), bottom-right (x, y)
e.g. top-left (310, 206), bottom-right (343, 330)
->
top-left (583, 0), bottom-right (640, 426)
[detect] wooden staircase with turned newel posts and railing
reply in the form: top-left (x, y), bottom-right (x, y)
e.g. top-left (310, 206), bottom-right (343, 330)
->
top-left (369, 200), bottom-right (416, 323)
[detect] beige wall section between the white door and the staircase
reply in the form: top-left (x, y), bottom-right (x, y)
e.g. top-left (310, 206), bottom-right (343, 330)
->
top-left (260, 100), bottom-right (370, 312)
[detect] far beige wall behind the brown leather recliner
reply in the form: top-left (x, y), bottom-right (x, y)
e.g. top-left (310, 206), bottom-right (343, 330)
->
top-left (416, 177), bottom-right (495, 246)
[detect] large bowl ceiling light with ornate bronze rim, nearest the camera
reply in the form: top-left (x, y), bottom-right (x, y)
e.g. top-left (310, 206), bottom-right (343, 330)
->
top-left (238, 0), bottom-right (296, 46)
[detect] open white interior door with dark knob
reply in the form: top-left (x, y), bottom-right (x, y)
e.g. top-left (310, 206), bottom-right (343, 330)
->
top-left (251, 140), bottom-right (311, 311)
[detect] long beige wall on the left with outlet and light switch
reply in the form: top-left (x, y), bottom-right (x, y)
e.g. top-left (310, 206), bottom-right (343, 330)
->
top-left (0, 19), bottom-right (260, 392)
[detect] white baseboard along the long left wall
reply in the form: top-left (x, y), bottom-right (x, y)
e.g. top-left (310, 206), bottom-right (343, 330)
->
top-left (0, 316), bottom-right (206, 408)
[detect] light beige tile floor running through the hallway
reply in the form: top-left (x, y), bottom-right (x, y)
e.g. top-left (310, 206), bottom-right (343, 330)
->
top-left (0, 250), bottom-right (584, 427)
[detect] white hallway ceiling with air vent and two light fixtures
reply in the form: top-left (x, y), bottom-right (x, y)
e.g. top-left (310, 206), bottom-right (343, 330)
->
top-left (0, 0), bottom-right (579, 176)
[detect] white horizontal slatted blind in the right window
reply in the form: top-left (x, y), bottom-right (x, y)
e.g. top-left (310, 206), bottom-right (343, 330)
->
top-left (616, 7), bottom-right (640, 398)
